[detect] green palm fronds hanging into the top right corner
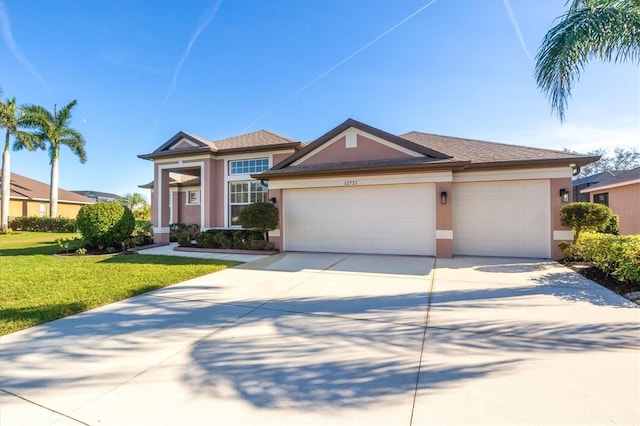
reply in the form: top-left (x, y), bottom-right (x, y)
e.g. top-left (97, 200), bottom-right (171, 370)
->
top-left (535, 0), bottom-right (640, 121)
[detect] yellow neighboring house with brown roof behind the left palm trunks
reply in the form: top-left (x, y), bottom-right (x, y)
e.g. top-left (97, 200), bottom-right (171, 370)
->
top-left (0, 173), bottom-right (94, 221)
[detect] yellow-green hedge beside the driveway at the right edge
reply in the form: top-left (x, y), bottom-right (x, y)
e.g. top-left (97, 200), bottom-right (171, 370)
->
top-left (574, 232), bottom-right (640, 282)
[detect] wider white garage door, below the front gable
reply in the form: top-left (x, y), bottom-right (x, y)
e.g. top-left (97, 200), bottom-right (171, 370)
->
top-left (283, 184), bottom-right (435, 256)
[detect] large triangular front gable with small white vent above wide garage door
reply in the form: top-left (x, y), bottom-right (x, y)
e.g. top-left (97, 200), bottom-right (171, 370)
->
top-left (272, 119), bottom-right (450, 170)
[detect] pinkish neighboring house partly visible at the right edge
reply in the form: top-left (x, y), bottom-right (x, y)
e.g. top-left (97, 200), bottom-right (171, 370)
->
top-left (580, 167), bottom-right (640, 235)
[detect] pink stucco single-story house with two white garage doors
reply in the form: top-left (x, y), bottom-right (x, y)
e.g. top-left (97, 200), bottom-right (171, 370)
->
top-left (139, 119), bottom-right (598, 258)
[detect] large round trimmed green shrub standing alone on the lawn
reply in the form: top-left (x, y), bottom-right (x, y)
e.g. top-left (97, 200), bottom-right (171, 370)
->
top-left (77, 203), bottom-right (135, 248)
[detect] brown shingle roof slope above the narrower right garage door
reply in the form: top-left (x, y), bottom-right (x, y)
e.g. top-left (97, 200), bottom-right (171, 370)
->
top-left (400, 132), bottom-right (585, 164)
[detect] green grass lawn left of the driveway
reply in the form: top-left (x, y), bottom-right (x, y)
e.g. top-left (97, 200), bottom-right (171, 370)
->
top-left (0, 232), bottom-right (239, 336)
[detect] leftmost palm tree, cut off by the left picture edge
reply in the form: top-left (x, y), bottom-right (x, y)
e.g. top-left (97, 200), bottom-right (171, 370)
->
top-left (0, 98), bottom-right (44, 229)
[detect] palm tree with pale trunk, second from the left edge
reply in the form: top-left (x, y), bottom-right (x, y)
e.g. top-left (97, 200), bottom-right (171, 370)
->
top-left (23, 99), bottom-right (87, 217)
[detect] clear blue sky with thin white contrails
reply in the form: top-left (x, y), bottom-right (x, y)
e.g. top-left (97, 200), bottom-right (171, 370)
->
top-left (0, 0), bottom-right (640, 196)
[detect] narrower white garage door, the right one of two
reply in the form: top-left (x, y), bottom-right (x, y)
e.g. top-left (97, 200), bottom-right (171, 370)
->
top-left (452, 180), bottom-right (550, 258)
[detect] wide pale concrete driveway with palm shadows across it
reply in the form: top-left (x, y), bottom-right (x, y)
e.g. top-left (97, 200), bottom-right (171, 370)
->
top-left (0, 253), bottom-right (640, 426)
